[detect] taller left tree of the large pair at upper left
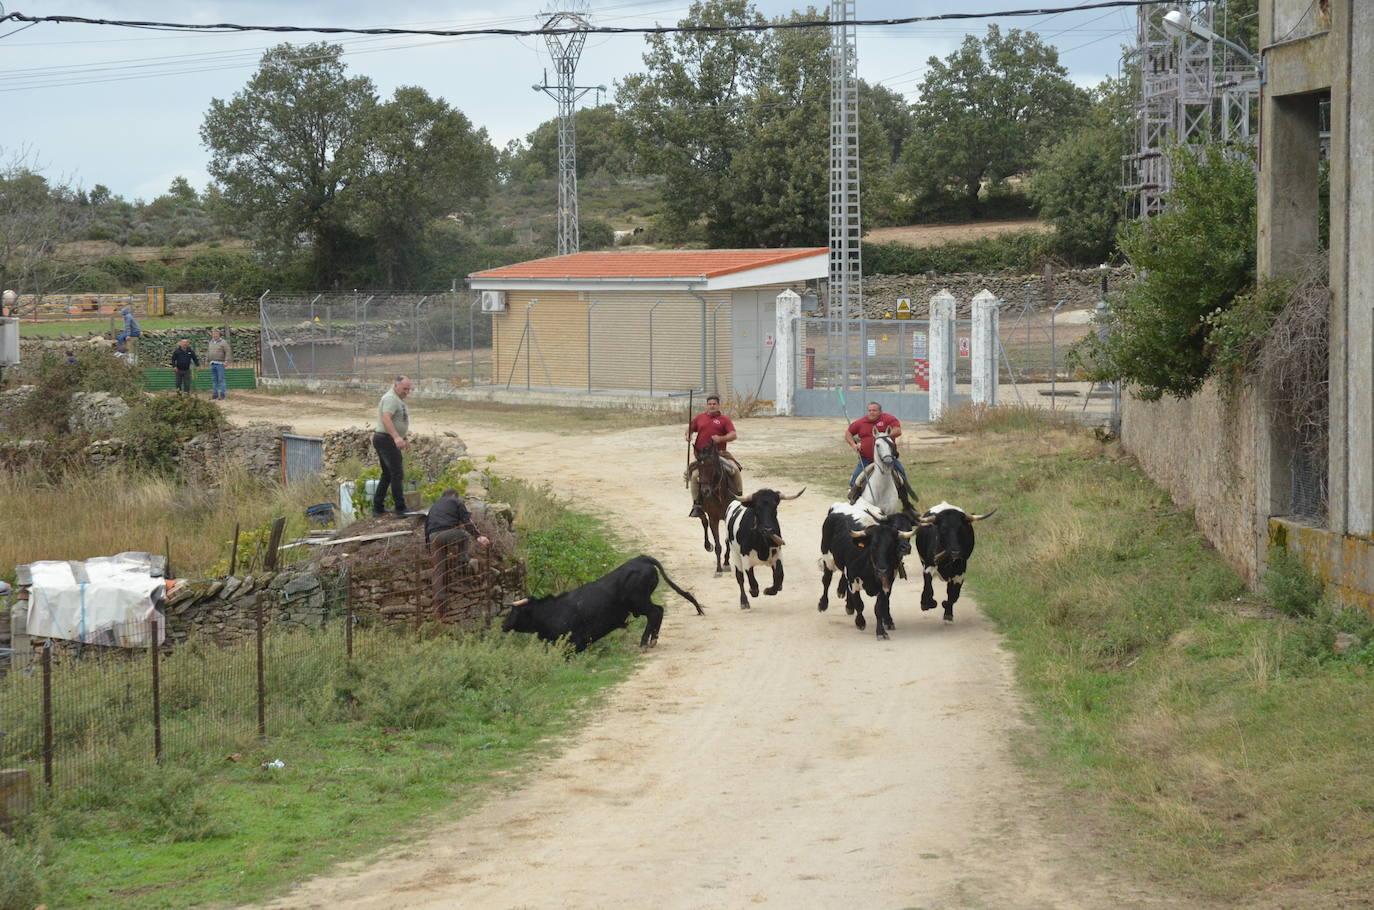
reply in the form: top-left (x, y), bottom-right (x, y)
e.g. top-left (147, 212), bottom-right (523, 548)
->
top-left (201, 43), bottom-right (376, 286)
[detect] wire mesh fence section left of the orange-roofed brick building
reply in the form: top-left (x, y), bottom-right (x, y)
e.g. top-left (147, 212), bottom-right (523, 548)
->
top-left (258, 291), bottom-right (492, 385)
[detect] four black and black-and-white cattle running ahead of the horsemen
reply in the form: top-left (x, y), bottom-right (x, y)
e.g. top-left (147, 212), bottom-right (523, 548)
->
top-left (503, 459), bottom-right (996, 652)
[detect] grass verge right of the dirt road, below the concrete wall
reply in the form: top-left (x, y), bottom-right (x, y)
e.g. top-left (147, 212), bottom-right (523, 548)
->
top-left (767, 414), bottom-right (1374, 907)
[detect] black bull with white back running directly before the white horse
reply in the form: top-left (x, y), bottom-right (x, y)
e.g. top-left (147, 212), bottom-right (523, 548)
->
top-left (816, 502), bottom-right (916, 638)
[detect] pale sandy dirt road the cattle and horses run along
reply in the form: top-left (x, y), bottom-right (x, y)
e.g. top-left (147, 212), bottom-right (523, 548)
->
top-left (229, 396), bottom-right (1167, 910)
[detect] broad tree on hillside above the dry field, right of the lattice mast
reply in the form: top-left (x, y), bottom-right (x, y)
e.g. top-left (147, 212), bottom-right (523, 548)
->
top-left (903, 25), bottom-right (1088, 214)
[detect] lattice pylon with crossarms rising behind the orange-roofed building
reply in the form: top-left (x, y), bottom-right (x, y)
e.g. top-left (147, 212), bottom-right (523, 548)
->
top-left (534, 0), bottom-right (606, 256)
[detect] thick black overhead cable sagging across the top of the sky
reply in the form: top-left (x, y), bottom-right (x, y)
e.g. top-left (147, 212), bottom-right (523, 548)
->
top-left (0, 0), bottom-right (1168, 38)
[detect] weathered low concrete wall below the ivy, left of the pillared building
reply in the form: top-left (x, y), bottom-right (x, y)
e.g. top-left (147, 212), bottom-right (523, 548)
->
top-left (1121, 382), bottom-right (1264, 586)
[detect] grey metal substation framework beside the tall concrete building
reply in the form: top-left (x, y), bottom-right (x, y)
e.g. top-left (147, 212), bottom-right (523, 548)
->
top-left (1123, 0), bottom-right (1260, 217)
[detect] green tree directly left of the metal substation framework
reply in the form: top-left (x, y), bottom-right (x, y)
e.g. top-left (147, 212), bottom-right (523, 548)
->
top-left (1029, 80), bottom-right (1128, 261)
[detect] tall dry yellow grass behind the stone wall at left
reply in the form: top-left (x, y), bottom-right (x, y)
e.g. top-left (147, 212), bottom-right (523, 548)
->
top-left (0, 470), bottom-right (328, 577)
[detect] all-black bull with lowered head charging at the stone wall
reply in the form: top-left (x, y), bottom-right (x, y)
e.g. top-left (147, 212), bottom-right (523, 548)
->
top-left (502, 555), bottom-right (703, 650)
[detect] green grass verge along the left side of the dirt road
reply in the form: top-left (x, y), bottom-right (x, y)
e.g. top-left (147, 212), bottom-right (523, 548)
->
top-left (0, 481), bottom-right (654, 910)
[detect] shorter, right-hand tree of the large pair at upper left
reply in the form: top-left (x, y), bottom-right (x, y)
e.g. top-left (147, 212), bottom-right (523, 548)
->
top-left (353, 87), bottom-right (496, 287)
